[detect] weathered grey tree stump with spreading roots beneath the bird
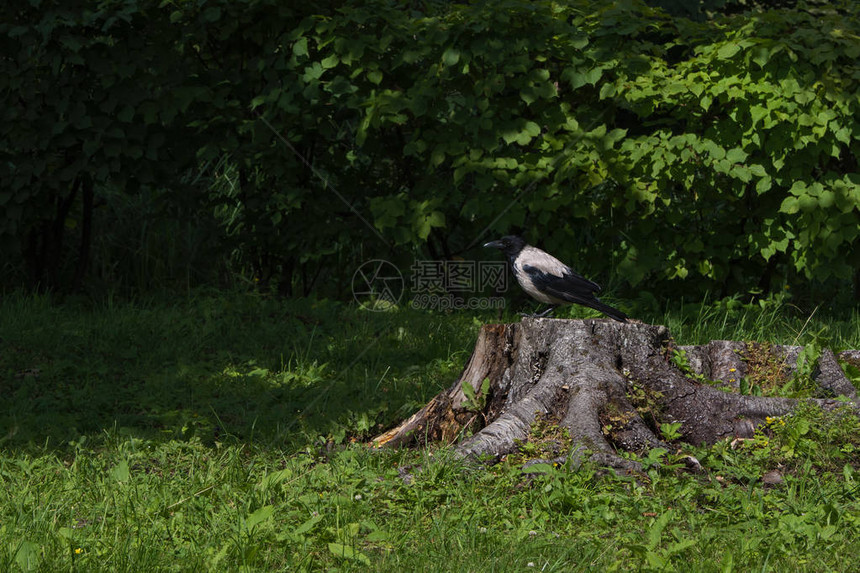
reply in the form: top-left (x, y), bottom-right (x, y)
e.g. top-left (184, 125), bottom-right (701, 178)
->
top-left (374, 318), bottom-right (858, 469)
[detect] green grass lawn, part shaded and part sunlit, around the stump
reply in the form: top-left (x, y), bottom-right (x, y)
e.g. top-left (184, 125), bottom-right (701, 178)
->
top-left (0, 292), bottom-right (860, 571)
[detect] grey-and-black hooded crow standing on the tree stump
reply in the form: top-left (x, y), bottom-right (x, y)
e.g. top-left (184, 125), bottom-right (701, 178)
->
top-left (484, 235), bottom-right (627, 322)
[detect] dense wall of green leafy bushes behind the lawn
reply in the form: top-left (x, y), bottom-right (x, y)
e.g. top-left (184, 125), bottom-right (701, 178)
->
top-left (0, 0), bottom-right (860, 293)
